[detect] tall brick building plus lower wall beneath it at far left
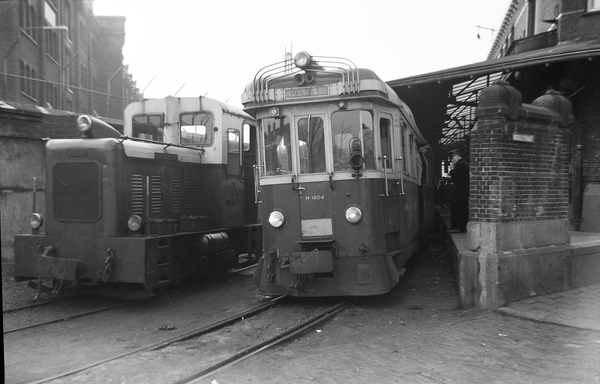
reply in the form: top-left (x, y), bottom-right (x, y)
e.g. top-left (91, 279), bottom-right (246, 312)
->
top-left (0, 0), bottom-right (141, 262)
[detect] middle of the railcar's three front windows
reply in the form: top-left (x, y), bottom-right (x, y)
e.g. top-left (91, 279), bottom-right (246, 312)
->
top-left (298, 117), bottom-right (325, 174)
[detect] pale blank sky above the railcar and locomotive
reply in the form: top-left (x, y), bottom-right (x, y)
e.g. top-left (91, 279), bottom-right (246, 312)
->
top-left (94, 0), bottom-right (510, 106)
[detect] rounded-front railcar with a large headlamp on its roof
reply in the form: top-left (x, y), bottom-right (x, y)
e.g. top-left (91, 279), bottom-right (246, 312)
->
top-left (242, 52), bottom-right (434, 297)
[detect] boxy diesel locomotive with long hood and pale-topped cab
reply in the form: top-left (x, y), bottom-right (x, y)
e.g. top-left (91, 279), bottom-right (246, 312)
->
top-left (14, 97), bottom-right (262, 298)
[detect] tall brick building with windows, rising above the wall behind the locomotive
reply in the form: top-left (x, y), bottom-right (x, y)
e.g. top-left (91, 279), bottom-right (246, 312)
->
top-left (0, 0), bottom-right (141, 126)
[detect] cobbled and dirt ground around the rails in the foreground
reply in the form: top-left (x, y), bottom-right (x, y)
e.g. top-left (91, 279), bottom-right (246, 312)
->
top-left (3, 234), bottom-right (600, 384)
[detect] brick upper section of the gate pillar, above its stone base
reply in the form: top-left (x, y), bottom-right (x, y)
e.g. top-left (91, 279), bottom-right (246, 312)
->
top-left (469, 83), bottom-right (572, 223)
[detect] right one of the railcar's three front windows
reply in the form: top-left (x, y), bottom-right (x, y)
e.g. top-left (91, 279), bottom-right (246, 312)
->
top-left (331, 111), bottom-right (375, 171)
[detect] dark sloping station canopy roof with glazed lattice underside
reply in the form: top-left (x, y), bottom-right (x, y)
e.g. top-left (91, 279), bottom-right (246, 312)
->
top-left (387, 41), bottom-right (600, 158)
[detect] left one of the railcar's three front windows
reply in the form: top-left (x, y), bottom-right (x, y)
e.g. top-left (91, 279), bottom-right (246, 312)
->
top-left (262, 117), bottom-right (292, 176)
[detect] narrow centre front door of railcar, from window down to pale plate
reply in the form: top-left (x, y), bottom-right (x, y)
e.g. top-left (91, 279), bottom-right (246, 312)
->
top-left (294, 114), bottom-right (333, 240)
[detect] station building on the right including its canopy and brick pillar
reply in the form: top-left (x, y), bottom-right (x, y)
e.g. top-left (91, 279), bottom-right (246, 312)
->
top-left (388, 0), bottom-right (600, 308)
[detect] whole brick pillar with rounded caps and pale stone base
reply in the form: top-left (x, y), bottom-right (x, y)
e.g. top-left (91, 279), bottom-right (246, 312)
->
top-left (459, 82), bottom-right (573, 308)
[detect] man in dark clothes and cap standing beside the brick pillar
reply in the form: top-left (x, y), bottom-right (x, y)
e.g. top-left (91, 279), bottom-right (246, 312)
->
top-left (450, 150), bottom-right (469, 232)
